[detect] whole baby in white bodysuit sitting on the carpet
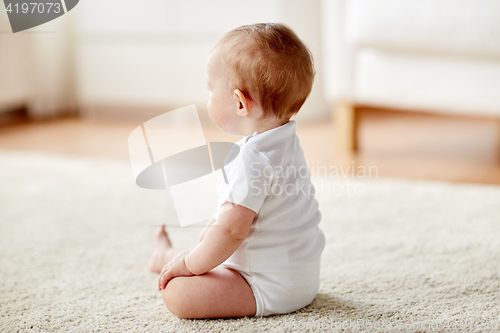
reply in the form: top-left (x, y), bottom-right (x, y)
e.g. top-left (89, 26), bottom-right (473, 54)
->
top-left (150, 23), bottom-right (325, 318)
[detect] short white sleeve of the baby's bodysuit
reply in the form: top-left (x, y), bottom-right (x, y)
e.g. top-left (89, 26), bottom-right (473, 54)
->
top-left (217, 145), bottom-right (275, 213)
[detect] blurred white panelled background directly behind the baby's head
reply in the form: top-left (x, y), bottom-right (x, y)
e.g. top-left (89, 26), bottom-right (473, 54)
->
top-left (76, 0), bottom-right (327, 119)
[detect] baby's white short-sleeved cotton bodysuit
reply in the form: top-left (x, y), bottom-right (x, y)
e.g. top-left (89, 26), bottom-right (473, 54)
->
top-left (214, 120), bottom-right (325, 316)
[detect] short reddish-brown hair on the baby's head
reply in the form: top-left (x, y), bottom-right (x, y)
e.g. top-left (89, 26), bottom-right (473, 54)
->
top-left (214, 23), bottom-right (315, 119)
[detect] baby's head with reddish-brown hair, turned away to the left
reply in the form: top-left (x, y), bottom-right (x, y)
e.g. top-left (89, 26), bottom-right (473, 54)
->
top-left (207, 23), bottom-right (315, 135)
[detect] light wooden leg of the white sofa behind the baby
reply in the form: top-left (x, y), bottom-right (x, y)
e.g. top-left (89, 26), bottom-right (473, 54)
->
top-left (334, 101), bottom-right (359, 153)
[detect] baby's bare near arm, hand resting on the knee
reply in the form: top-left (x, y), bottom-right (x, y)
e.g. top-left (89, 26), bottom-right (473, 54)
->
top-left (158, 202), bottom-right (255, 289)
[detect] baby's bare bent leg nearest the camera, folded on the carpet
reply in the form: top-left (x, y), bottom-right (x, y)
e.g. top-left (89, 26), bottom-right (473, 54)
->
top-left (162, 266), bottom-right (257, 319)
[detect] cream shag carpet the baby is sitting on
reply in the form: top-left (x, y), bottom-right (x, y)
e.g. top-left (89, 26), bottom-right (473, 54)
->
top-left (0, 151), bottom-right (500, 332)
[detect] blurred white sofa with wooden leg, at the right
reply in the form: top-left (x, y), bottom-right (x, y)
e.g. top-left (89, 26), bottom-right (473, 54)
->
top-left (322, 0), bottom-right (500, 151)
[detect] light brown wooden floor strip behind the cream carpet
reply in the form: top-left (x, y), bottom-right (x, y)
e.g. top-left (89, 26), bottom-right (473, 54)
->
top-left (0, 111), bottom-right (500, 184)
